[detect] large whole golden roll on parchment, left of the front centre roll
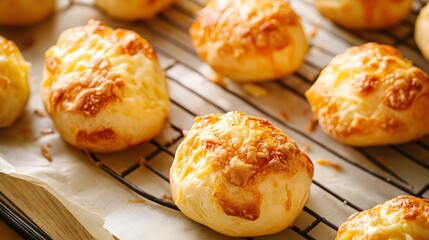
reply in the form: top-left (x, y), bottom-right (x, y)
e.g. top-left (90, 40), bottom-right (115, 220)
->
top-left (42, 20), bottom-right (169, 152)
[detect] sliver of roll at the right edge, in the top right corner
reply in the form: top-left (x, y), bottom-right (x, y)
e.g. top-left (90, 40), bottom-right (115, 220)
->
top-left (414, 3), bottom-right (429, 60)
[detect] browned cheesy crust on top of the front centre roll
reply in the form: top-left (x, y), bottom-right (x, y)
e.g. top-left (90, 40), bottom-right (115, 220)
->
top-left (194, 112), bottom-right (312, 187)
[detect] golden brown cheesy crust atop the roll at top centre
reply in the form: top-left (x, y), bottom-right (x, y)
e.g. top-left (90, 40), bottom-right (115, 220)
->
top-left (189, 1), bottom-right (300, 59)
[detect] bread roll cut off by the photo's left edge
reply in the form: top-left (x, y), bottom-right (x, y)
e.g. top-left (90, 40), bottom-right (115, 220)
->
top-left (0, 36), bottom-right (30, 127)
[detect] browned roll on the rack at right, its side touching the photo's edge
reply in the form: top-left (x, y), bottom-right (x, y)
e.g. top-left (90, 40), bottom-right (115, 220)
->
top-left (305, 43), bottom-right (429, 146)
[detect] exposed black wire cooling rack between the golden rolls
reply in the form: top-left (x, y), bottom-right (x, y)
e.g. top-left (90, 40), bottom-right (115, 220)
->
top-left (81, 0), bottom-right (429, 239)
